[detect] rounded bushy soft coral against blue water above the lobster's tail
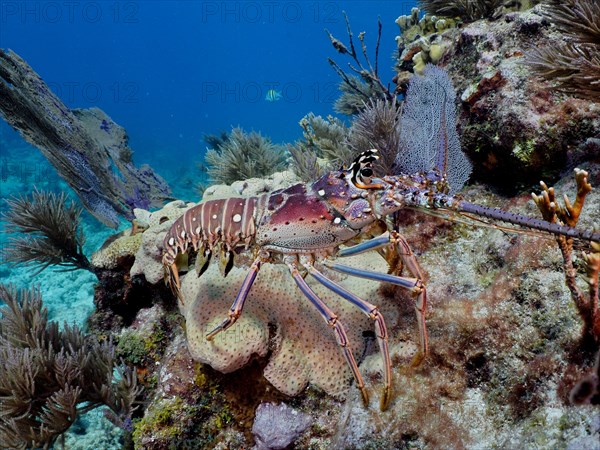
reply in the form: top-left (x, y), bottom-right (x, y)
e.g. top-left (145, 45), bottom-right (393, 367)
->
top-left (204, 127), bottom-right (286, 184)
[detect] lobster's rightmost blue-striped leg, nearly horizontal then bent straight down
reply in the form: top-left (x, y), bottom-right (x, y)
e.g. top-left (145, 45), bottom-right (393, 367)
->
top-left (324, 256), bottom-right (429, 364)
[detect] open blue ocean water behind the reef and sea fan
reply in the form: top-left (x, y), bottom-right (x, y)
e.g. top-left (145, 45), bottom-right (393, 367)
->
top-left (0, 0), bottom-right (415, 324)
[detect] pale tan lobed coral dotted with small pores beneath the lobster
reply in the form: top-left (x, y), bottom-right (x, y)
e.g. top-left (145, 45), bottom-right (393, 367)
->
top-left (181, 254), bottom-right (397, 397)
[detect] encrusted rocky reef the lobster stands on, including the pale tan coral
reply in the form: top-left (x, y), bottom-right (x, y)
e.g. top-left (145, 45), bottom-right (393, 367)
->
top-left (91, 163), bottom-right (600, 449)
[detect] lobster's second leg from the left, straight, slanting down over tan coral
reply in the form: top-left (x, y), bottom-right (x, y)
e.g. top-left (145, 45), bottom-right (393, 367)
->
top-left (286, 258), bottom-right (369, 406)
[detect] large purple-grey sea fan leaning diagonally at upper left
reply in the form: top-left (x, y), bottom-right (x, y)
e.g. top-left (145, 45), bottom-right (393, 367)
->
top-left (0, 50), bottom-right (170, 228)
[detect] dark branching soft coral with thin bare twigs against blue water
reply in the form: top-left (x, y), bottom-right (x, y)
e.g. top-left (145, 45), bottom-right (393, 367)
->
top-left (325, 12), bottom-right (394, 115)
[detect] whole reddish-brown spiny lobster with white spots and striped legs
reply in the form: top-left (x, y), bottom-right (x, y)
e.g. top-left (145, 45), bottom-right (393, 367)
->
top-left (163, 150), bottom-right (600, 410)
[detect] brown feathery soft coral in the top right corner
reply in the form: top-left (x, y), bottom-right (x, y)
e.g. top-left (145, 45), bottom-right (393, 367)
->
top-left (527, 0), bottom-right (600, 101)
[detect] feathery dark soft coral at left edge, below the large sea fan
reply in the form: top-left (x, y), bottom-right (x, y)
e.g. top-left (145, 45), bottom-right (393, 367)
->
top-left (3, 190), bottom-right (94, 273)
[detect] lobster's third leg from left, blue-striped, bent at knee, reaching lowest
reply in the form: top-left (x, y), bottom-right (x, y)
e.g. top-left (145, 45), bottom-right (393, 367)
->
top-left (307, 265), bottom-right (392, 411)
